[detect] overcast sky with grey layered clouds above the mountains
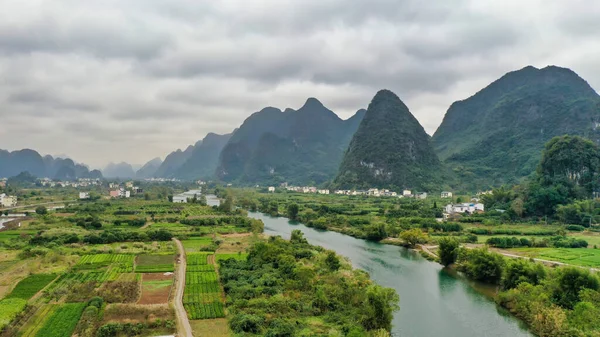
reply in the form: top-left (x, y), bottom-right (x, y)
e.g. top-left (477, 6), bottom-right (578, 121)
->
top-left (0, 0), bottom-right (600, 168)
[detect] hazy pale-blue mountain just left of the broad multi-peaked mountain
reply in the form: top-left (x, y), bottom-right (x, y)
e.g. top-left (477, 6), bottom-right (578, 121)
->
top-left (173, 133), bottom-right (231, 180)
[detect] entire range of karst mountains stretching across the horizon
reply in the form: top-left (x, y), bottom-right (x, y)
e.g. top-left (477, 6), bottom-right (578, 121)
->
top-left (0, 66), bottom-right (600, 190)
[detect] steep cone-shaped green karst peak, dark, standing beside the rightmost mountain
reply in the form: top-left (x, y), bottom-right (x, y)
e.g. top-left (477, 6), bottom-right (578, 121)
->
top-left (334, 90), bottom-right (443, 191)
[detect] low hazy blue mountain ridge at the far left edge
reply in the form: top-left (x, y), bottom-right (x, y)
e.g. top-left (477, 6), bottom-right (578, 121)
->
top-left (0, 149), bottom-right (102, 180)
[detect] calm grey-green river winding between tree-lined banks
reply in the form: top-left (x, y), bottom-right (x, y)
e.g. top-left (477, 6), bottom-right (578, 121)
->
top-left (209, 199), bottom-right (533, 337)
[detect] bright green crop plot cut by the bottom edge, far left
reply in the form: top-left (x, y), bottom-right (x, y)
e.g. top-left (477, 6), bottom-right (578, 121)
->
top-left (36, 303), bottom-right (86, 337)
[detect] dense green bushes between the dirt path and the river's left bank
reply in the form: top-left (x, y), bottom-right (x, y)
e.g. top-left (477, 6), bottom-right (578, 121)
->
top-left (219, 235), bottom-right (398, 336)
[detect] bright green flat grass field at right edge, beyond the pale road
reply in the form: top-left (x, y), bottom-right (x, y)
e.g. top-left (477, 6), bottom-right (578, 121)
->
top-left (510, 248), bottom-right (600, 268)
